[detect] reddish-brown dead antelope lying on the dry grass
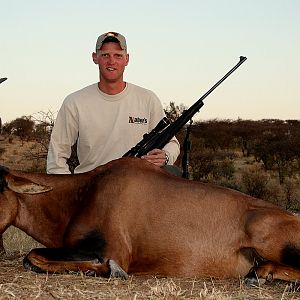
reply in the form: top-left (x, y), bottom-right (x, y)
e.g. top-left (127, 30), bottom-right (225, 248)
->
top-left (0, 158), bottom-right (300, 283)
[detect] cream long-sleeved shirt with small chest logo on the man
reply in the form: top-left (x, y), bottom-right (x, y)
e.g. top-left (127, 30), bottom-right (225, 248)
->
top-left (47, 83), bottom-right (180, 174)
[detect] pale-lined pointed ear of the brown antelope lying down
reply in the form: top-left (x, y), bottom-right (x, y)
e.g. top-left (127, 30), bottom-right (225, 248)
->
top-left (6, 175), bottom-right (52, 194)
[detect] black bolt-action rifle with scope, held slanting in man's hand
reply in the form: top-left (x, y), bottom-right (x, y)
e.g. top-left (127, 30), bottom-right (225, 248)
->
top-left (123, 56), bottom-right (247, 157)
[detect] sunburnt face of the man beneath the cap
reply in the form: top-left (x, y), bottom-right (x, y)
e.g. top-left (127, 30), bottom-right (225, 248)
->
top-left (93, 42), bottom-right (129, 82)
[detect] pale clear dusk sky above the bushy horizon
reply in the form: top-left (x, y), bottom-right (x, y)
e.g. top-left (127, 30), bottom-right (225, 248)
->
top-left (0, 0), bottom-right (300, 123)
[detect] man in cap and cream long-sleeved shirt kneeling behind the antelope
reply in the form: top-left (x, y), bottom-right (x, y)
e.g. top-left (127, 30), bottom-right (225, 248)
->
top-left (47, 32), bottom-right (180, 174)
